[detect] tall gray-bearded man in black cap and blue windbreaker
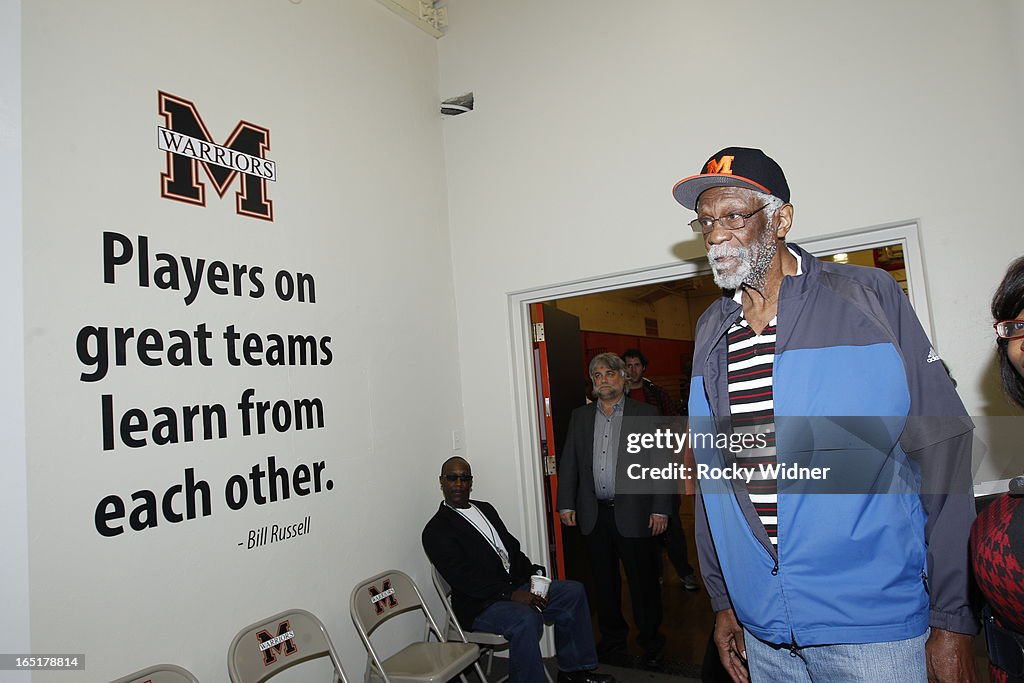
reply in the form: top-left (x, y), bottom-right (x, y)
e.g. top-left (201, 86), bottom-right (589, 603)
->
top-left (673, 147), bottom-right (977, 683)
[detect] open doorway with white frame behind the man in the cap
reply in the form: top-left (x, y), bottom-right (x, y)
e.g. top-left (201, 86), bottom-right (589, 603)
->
top-left (509, 222), bottom-right (932, 675)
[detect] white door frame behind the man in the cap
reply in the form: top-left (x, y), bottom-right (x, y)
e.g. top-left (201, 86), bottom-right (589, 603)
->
top-left (508, 220), bottom-right (935, 577)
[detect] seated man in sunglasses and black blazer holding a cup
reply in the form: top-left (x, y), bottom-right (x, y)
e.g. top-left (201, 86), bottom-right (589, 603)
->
top-left (423, 457), bottom-right (614, 683)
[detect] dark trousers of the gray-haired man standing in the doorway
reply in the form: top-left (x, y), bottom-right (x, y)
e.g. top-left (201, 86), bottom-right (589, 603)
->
top-left (585, 505), bottom-right (665, 653)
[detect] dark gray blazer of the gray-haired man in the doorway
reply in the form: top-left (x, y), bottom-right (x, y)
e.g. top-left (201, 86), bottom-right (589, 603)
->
top-left (557, 396), bottom-right (672, 539)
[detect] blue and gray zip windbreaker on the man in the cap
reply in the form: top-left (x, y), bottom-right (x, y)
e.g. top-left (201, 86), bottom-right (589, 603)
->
top-left (689, 245), bottom-right (977, 646)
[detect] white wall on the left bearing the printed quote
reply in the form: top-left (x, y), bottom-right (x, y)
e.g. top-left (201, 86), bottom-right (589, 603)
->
top-left (18, 0), bottom-right (462, 681)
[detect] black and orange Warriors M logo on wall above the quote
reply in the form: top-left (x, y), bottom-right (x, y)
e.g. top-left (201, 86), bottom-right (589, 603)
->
top-left (157, 91), bottom-right (278, 220)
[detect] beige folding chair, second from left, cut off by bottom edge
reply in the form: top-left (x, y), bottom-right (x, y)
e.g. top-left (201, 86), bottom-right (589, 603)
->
top-left (228, 609), bottom-right (348, 683)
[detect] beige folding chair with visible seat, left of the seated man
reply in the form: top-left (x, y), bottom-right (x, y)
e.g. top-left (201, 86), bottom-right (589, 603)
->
top-left (349, 569), bottom-right (486, 683)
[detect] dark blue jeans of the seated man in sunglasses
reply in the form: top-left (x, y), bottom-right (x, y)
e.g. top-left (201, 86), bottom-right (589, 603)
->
top-left (472, 581), bottom-right (597, 683)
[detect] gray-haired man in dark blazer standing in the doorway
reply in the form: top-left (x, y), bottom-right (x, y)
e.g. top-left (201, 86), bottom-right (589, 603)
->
top-left (558, 353), bottom-right (672, 668)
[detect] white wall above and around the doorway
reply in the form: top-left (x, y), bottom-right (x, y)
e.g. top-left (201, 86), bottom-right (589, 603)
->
top-left (438, 0), bottom-right (1024, 552)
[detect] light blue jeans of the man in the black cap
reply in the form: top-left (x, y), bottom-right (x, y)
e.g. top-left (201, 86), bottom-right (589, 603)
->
top-left (743, 630), bottom-right (930, 683)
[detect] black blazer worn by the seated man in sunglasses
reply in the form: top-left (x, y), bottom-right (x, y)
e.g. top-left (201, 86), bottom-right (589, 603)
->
top-left (422, 500), bottom-right (543, 629)
